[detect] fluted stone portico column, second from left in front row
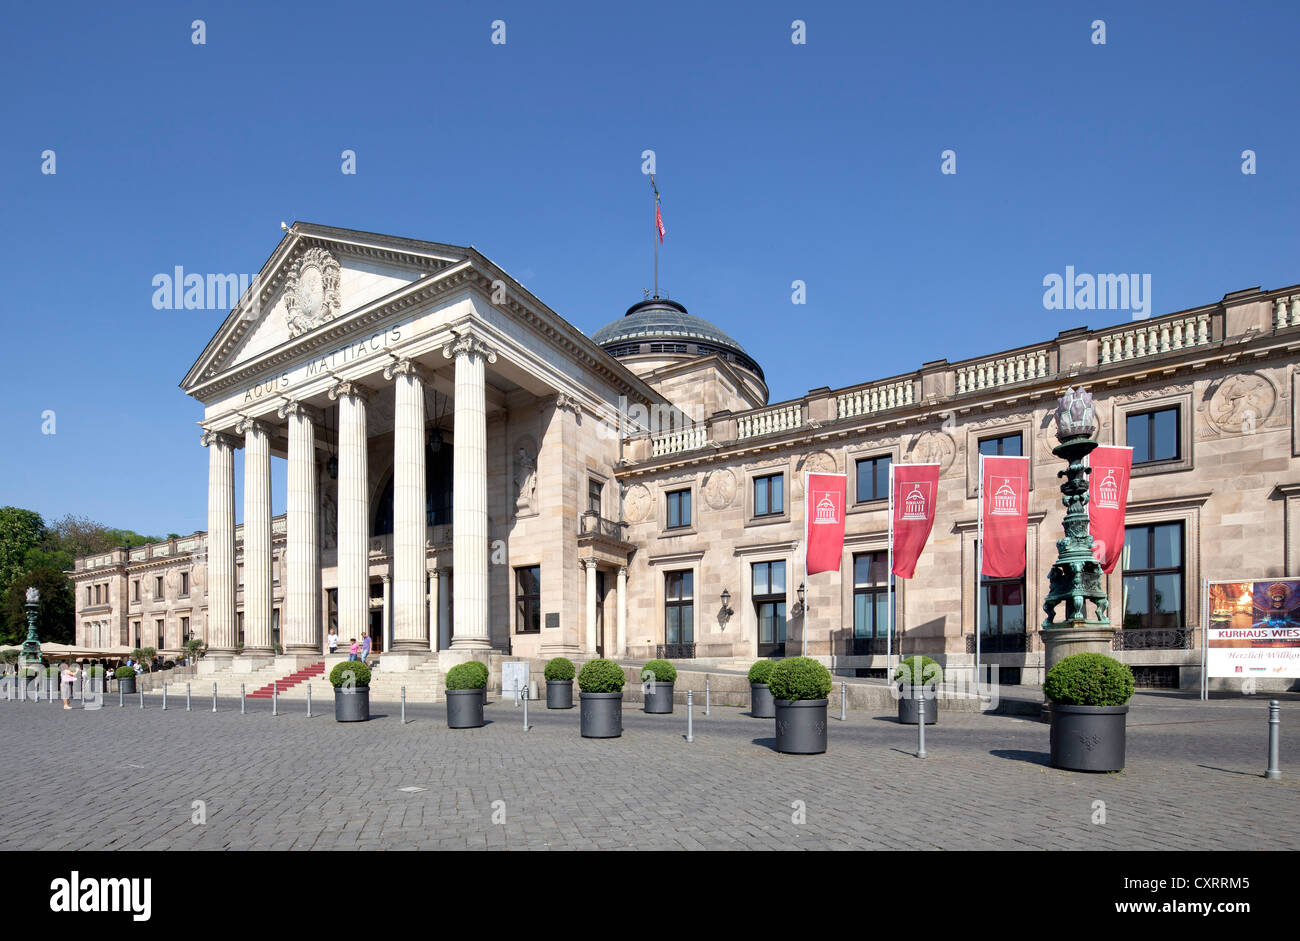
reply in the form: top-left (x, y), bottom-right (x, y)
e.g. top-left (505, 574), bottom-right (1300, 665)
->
top-left (235, 419), bottom-right (273, 654)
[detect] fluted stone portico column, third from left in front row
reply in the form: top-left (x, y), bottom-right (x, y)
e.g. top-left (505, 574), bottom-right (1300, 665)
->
top-left (280, 402), bottom-right (321, 655)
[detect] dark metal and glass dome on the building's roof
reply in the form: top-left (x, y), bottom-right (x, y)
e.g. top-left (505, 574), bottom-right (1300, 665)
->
top-left (592, 298), bottom-right (763, 380)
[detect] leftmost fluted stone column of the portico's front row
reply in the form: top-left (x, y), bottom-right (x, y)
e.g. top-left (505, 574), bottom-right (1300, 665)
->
top-left (202, 432), bottom-right (237, 660)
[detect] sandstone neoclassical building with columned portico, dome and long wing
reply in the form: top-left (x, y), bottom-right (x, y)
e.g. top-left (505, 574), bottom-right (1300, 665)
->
top-left (70, 224), bottom-right (1300, 686)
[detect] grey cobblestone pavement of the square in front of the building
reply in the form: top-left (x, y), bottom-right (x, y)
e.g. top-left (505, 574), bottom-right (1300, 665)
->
top-left (0, 695), bottom-right (1300, 850)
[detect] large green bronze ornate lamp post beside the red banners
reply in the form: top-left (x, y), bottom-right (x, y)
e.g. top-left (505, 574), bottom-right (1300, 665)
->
top-left (1043, 387), bottom-right (1114, 669)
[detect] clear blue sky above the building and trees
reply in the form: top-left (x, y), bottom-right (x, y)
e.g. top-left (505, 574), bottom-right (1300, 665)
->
top-left (0, 0), bottom-right (1300, 534)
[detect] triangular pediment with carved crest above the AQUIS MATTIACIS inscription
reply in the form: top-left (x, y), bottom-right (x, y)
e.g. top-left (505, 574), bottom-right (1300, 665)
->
top-left (181, 222), bottom-right (468, 393)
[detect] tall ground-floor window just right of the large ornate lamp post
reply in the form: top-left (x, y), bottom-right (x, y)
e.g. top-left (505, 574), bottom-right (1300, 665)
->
top-left (1123, 522), bottom-right (1183, 629)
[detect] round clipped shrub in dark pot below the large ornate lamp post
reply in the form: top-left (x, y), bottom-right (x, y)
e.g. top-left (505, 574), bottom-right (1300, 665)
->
top-left (1043, 654), bottom-right (1134, 771)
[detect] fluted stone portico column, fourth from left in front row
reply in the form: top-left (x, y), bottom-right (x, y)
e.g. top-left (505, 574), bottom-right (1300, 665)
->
top-left (329, 381), bottom-right (371, 646)
